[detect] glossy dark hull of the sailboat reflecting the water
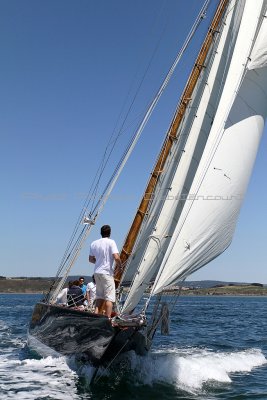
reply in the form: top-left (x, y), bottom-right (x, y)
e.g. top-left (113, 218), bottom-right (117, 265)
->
top-left (29, 303), bottom-right (147, 366)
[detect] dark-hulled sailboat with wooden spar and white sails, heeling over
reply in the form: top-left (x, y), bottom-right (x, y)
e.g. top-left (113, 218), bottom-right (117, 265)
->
top-left (29, 0), bottom-right (267, 374)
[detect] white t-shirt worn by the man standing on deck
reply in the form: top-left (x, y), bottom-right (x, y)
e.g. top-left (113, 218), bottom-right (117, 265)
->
top-left (90, 238), bottom-right (119, 276)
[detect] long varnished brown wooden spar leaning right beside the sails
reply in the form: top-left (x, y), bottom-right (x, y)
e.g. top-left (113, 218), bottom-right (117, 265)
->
top-left (114, 0), bottom-right (229, 286)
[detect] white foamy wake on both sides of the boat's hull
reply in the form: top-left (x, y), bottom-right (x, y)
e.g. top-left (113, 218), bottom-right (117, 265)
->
top-left (0, 348), bottom-right (267, 400)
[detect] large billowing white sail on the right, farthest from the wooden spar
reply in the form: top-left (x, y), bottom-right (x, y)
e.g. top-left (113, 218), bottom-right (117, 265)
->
top-left (152, 0), bottom-right (267, 294)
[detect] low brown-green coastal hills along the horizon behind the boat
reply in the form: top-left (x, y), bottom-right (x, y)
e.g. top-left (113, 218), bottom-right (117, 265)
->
top-left (0, 276), bottom-right (267, 296)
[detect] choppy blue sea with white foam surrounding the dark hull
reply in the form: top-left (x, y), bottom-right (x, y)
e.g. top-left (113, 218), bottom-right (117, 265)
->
top-left (0, 294), bottom-right (267, 400)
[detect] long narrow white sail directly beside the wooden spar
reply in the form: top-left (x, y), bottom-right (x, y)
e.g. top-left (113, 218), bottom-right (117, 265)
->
top-left (121, 0), bottom-right (237, 311)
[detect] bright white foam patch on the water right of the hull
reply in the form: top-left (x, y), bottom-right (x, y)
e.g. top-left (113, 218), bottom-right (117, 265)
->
top-left (129, 349), bottom-right (267, 391)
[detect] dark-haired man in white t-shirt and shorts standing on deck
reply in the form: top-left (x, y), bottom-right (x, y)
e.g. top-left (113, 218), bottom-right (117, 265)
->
top-left (89, 225), bottom-right (121, 318)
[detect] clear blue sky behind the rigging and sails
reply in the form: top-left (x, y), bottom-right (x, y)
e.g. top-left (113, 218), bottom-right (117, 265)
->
top-left (0, 0), bottom-right (267, 283)
